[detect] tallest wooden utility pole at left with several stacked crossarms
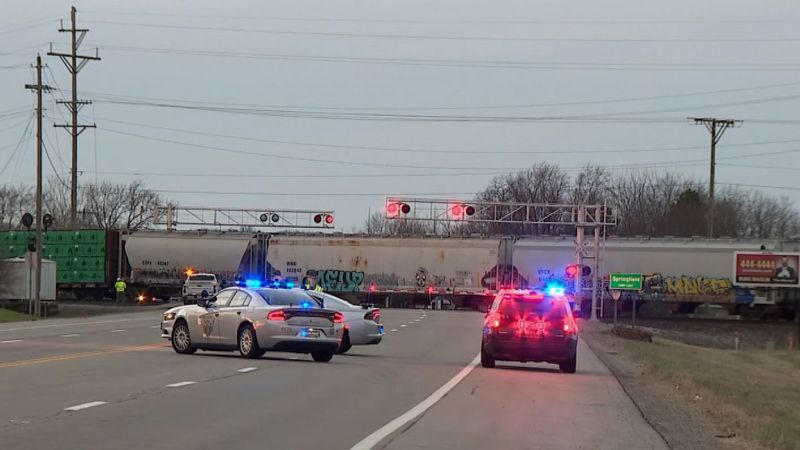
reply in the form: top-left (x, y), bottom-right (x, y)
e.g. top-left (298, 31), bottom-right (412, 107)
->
top-left (47, 6), bottom-right (100, 229)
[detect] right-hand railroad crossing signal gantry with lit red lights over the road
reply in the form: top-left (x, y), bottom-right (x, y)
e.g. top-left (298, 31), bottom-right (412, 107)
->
top-left (386, 197), bottom-right (617, 320)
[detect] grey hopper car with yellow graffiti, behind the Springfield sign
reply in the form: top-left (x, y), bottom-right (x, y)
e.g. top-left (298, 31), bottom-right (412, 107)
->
top-left (514, 237), bottom-right (798, 312)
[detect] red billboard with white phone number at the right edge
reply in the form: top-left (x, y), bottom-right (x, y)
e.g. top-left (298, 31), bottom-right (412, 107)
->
top-left (733, 252), bottom-right (800, 287)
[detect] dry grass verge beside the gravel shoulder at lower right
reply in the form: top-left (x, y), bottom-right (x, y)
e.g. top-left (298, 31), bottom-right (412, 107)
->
top-left (603, 333), bottom-right (800, 450)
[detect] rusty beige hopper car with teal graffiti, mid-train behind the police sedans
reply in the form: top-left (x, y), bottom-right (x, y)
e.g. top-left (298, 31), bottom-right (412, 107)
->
top-left (268, 235), bottom-right (498, 306)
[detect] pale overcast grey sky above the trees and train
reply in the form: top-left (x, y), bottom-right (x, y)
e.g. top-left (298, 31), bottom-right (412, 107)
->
top-left (0, 0), bottom-right (800, 231)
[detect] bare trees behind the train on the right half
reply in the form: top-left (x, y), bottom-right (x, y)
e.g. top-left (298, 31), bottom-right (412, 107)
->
top-left (361, 163), bottom-right (800, 239)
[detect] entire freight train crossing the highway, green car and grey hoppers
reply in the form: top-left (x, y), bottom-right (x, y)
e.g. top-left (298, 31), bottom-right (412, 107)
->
top-left (0, 230), bottom-right (800, 313)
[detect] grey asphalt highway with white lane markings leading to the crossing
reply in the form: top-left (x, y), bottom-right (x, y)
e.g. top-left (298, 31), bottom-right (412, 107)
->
top-left (0, 310), bottom-right (667, 450)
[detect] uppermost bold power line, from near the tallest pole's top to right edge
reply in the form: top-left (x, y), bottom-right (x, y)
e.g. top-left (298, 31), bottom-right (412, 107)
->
top-left (83, 20), bottom-right (800, 44)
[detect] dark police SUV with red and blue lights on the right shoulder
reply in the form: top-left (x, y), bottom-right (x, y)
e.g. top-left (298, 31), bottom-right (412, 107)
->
top-left (481, 290), bottom-right (578, 373)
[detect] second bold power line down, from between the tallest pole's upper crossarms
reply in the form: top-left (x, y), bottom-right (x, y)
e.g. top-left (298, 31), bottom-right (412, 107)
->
top-left (95, 44), bottom-right (800, 72)
